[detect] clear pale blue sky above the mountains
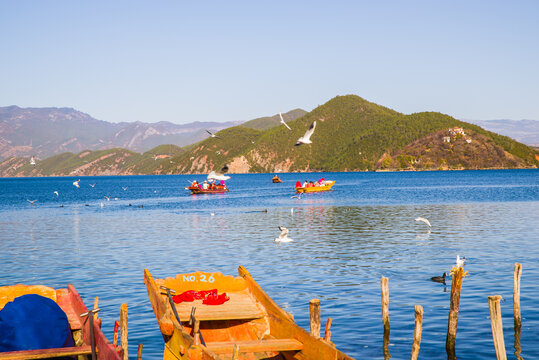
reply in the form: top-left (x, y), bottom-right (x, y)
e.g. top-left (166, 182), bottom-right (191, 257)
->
top-left (0, 0), bottom-right (539, 123)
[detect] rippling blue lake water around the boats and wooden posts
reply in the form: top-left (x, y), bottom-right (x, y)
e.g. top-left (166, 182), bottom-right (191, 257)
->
top-left (0, 170), bottom-right (539, 359)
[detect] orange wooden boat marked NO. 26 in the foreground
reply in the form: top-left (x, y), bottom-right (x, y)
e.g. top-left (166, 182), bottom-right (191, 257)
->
top-left (144, 266), bottom-right (352, 360)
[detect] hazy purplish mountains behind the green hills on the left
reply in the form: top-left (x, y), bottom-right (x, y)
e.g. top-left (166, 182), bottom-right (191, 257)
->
top-left (0, 106), bottom-right (240, 159)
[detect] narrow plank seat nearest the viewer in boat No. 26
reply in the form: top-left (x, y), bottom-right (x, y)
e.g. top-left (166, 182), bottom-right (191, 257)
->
top-left (206, 339), bottom-right (303, 354)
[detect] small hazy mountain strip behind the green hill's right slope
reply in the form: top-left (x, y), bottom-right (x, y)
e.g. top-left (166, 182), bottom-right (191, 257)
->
top-left (466, 120), bottom-right (539, 147)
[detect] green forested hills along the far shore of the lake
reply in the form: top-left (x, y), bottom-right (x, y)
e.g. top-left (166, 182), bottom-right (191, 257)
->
top-left (0, 95), bottom-right (539, 177)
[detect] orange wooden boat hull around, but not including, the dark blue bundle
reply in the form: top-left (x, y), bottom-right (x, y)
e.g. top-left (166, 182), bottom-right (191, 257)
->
top-left (0, 284), bottom-right (122, 360)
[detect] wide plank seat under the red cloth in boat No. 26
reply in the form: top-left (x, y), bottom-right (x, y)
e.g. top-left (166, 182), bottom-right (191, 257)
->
top-left (176, 290), bottom-right (265, 322)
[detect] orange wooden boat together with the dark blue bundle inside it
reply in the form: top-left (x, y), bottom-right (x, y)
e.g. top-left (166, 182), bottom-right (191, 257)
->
top-left (0, 284), bottom-right (122, 360)
